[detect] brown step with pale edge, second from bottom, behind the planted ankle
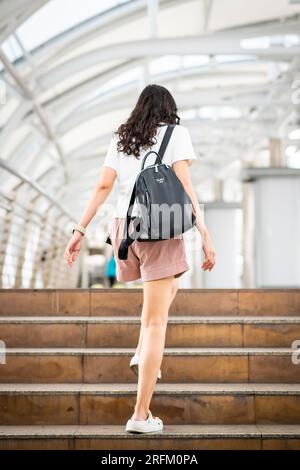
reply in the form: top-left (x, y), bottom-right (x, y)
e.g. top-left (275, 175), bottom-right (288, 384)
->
top-left (0, 383), bottom-right (300, 425)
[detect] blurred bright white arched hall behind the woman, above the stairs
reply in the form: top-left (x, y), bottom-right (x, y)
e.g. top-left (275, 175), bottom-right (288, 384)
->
top-left (0, 0), bottom-right (300, 288)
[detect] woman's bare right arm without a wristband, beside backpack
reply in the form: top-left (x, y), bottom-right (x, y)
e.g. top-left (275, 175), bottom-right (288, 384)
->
top-left (172, 160), bottom-right (216, 271)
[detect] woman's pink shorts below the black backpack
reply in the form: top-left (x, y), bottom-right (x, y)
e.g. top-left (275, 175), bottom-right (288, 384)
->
top-left (110, 218), bottom-right (189, 282)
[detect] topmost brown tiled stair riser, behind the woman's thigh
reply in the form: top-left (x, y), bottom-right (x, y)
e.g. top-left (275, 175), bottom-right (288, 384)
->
top-left (0, 289), bottom-right (300, 316)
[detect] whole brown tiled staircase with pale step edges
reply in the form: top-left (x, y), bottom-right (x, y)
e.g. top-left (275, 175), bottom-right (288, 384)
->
top-left (0, 289), bottom-right (300, 450)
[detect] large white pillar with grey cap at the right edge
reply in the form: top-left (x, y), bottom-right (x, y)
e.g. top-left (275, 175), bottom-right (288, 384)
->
top-left (242, 168), bottom-right (300, 288)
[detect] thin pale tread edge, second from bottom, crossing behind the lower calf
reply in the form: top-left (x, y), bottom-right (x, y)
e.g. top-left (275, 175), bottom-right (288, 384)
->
top-left (0, 383), bottom-right (300, 395)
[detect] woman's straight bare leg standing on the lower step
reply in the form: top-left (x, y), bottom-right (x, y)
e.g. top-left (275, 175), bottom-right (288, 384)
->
top-left (132, 276), bottom-right (174, 420)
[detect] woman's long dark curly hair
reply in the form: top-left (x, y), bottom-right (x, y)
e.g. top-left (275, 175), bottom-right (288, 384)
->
top-left (114, 85), bottom-right (180, 158)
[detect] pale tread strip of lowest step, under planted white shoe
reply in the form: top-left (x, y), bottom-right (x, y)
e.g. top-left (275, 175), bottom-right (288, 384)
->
top-left (0, 424), bottom-right (300, 439)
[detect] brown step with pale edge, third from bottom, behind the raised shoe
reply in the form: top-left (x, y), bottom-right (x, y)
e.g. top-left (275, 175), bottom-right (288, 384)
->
top-left (0, 348), bottom-right (300, 383)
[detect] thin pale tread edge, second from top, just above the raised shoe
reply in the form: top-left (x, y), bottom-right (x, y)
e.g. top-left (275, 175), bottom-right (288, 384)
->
top-left (6, 347), bottom-right (293, 356)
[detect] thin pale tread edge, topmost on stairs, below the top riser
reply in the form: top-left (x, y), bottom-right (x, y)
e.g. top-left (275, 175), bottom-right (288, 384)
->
top-left (0, 314), bottom-right (300, 325)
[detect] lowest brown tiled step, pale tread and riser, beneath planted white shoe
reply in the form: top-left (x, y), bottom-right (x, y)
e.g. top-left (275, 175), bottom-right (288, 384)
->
top-left (0, 424), bottom-right (300, 450)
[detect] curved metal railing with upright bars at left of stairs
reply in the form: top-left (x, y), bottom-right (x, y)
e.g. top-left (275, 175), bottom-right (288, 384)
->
top-left (0, 159), bottom-right (83, 288)
